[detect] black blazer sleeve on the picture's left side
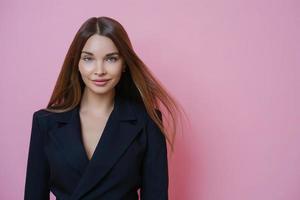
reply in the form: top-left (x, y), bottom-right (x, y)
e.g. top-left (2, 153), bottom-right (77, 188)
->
top-left (24, 111), bottom-right (50, 200)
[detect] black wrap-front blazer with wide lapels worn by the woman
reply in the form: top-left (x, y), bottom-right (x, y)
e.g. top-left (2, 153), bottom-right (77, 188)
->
top-left (24, 95), bottom-right (169, 200)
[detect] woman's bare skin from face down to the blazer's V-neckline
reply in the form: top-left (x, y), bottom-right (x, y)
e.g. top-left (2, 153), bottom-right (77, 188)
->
top-left (78, 34), bottom-right (125, 160)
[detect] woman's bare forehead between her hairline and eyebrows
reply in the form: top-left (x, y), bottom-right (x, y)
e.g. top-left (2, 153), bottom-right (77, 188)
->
top-left (82, 34), bottom-right (118, 56)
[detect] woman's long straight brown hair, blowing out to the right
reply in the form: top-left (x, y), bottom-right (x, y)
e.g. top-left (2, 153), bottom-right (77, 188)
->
top-left (45, 16), bottom-right (183, 152)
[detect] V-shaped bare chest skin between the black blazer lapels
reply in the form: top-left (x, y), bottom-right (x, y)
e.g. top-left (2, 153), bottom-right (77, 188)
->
top-left (80, 113), bottom-right (108, 160)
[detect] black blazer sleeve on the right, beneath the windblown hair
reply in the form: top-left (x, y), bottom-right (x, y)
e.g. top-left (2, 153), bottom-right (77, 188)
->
top-left (140, 110), bottom-right (169, 200)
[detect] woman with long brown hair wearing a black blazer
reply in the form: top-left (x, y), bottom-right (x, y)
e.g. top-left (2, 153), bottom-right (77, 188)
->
top-left (24, 17), bottom-right (185, 200)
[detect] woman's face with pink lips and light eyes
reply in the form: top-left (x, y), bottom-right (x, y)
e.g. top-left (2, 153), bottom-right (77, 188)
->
top-left (78, 34), bottom-right (125, 94)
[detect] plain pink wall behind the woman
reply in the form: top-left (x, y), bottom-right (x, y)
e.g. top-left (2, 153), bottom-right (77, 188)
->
top-left (0, 0), bottom-right (300, 200)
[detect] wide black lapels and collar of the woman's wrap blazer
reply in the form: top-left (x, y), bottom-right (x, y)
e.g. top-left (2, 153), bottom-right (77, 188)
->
top-left (49, 95), bottom-right (145, 200)
